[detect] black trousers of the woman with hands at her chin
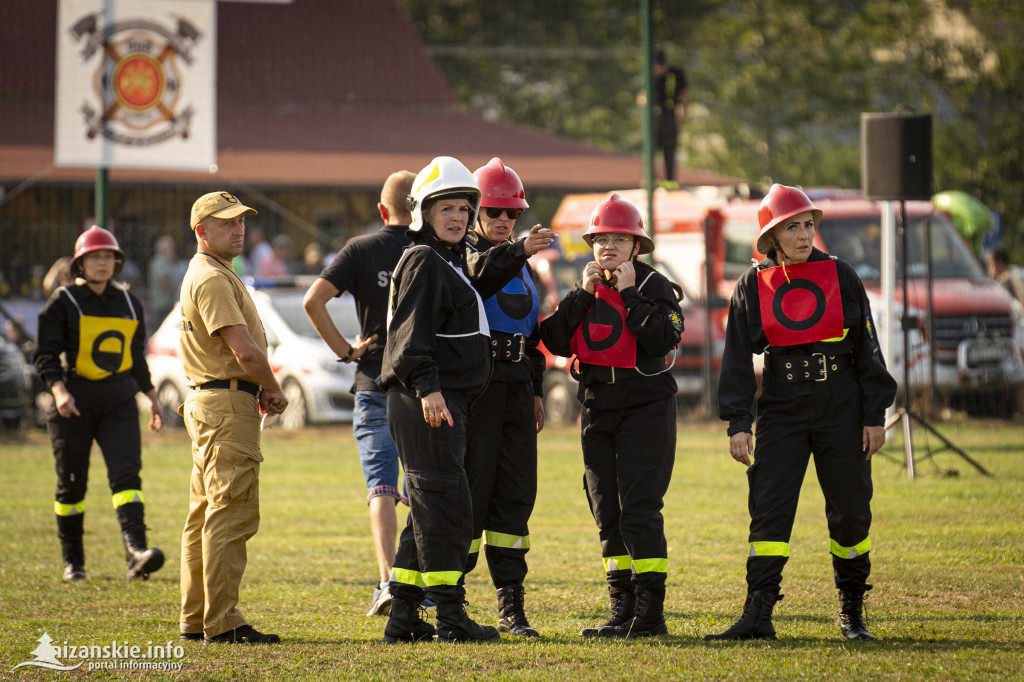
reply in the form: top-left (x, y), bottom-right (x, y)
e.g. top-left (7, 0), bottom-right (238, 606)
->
top-left (582, 395), bottom-right (676, 588)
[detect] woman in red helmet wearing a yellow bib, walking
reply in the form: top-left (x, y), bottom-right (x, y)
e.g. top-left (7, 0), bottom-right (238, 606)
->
top-left (36, 225), bottom-right (164, 581)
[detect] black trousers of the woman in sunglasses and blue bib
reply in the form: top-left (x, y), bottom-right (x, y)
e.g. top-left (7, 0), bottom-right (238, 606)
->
top-left (466, 382), bottom-right (537, 588)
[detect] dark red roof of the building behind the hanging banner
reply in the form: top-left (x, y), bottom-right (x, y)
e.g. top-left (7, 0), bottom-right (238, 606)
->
top-left (0, 0), bottom-right (738, 190)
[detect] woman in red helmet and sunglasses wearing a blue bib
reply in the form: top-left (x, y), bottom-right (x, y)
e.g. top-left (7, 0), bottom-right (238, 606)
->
top-left (466, 157), bottom-right (554, 637)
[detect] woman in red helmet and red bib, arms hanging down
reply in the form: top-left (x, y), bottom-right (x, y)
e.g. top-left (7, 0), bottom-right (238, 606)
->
top-left (705, 184), bottom-right (896, 641)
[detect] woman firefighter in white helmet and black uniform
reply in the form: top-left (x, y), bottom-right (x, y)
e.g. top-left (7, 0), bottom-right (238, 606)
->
top-left (380, 157), bottom-right (548, 642)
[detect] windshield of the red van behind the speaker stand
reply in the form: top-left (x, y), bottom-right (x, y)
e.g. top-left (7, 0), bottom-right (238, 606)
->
top-left (818, 214), bottom-right (985, 280)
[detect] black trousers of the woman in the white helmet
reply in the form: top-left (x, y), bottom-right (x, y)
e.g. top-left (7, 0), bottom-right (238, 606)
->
top-left (387, 388), bottom-right (473, 599)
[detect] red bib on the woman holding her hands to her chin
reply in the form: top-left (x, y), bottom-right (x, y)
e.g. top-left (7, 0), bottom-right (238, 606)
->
top-left (569, 284), bottom-right (637, 368)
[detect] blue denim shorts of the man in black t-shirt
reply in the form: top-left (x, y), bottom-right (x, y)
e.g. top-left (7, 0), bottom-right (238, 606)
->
top-left (352, 391), bottom-right (408, 504)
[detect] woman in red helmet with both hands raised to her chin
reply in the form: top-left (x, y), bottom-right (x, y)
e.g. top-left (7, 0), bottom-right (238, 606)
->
top-left (541, 194), bottom-right (683, 638)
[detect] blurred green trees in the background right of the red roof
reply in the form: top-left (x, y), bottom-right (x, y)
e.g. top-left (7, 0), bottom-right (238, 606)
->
top-left (402, 0), bottom-right (1024, 260)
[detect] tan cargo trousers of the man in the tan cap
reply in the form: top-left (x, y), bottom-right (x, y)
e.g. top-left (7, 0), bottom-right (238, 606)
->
top-left (178, 388), bottom-right (263, 638)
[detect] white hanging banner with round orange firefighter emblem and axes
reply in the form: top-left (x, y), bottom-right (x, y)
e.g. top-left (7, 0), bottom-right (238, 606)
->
top-left (53, 0), bottom-right (217, 170)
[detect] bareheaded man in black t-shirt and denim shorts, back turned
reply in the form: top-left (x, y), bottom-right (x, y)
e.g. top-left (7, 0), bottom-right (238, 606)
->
top-left (302, 171), bottom-right (416, 615)
